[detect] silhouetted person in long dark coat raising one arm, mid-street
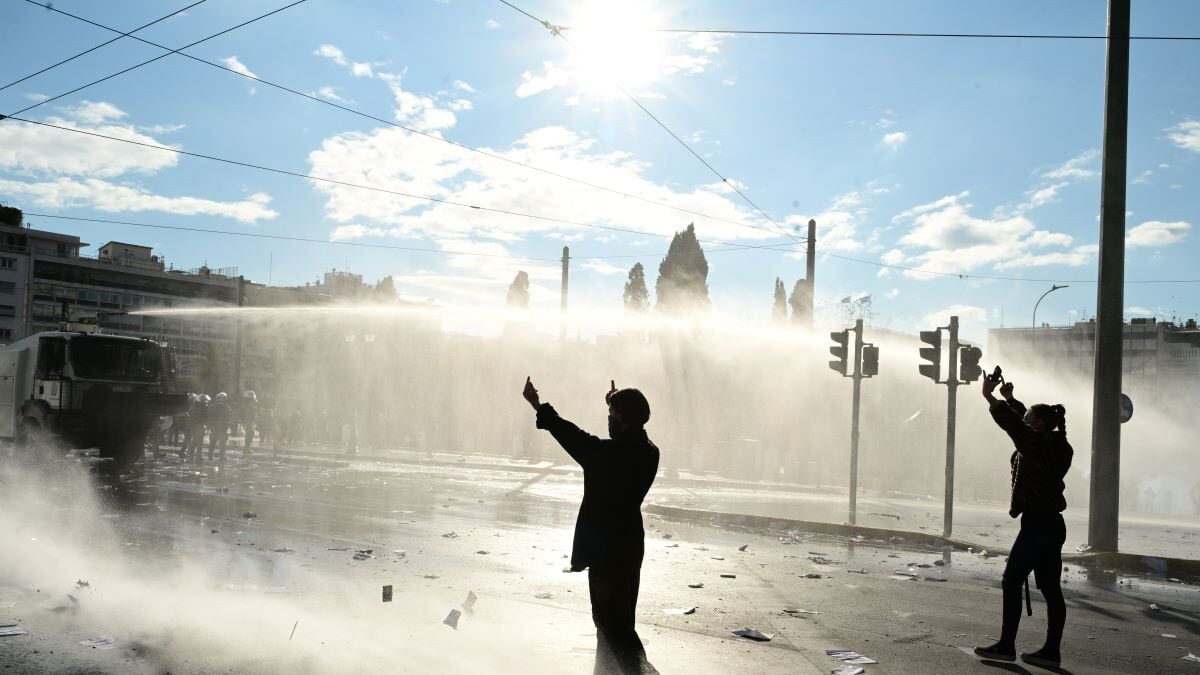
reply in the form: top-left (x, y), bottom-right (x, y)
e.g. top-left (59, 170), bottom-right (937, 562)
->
top-left (523, 378), bottom-right (659, 675)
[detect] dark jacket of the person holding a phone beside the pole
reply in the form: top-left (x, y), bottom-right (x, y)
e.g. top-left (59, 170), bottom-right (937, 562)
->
top-left (991, 399), bottom-right (1075, 518)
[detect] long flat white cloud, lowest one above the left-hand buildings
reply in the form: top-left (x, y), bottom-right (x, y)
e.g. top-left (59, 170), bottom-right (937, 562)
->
top-left (0, 178), bottom-right (278, 223)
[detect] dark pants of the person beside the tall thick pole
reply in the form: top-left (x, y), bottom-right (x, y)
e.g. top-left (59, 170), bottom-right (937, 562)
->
top-left (1000, 513), bottom-right (1067, 653)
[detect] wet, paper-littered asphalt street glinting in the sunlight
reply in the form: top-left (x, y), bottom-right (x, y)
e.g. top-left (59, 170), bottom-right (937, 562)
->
top-left (0, 444), bottom-right (1200, 674)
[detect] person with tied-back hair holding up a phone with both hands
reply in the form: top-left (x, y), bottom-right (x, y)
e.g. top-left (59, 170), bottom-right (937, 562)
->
top-left (974, 377), bottom-right (1074, 668)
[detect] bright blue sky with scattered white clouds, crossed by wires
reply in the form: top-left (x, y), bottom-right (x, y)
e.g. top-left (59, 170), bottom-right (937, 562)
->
top-left (0, 0), bottom-right (1200, 336)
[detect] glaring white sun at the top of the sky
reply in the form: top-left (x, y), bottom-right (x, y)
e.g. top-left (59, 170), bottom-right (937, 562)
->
top-left (564, 0), bottom-right (666, 97)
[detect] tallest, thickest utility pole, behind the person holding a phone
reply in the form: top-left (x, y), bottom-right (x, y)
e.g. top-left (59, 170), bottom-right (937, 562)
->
top-left (1087, 0), bottom-right (1129, 552)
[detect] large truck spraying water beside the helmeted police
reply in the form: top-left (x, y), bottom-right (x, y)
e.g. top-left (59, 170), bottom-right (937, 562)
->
top-left (0, 324), bottom-right (187, 468)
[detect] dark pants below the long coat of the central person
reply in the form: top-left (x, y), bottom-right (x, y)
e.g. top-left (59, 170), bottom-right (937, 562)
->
top-left (588, 554), bottom-right (656, 675)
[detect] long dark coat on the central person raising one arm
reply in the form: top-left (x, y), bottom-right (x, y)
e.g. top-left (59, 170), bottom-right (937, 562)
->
top-left (538, 404), bottom-right (659, 572)
